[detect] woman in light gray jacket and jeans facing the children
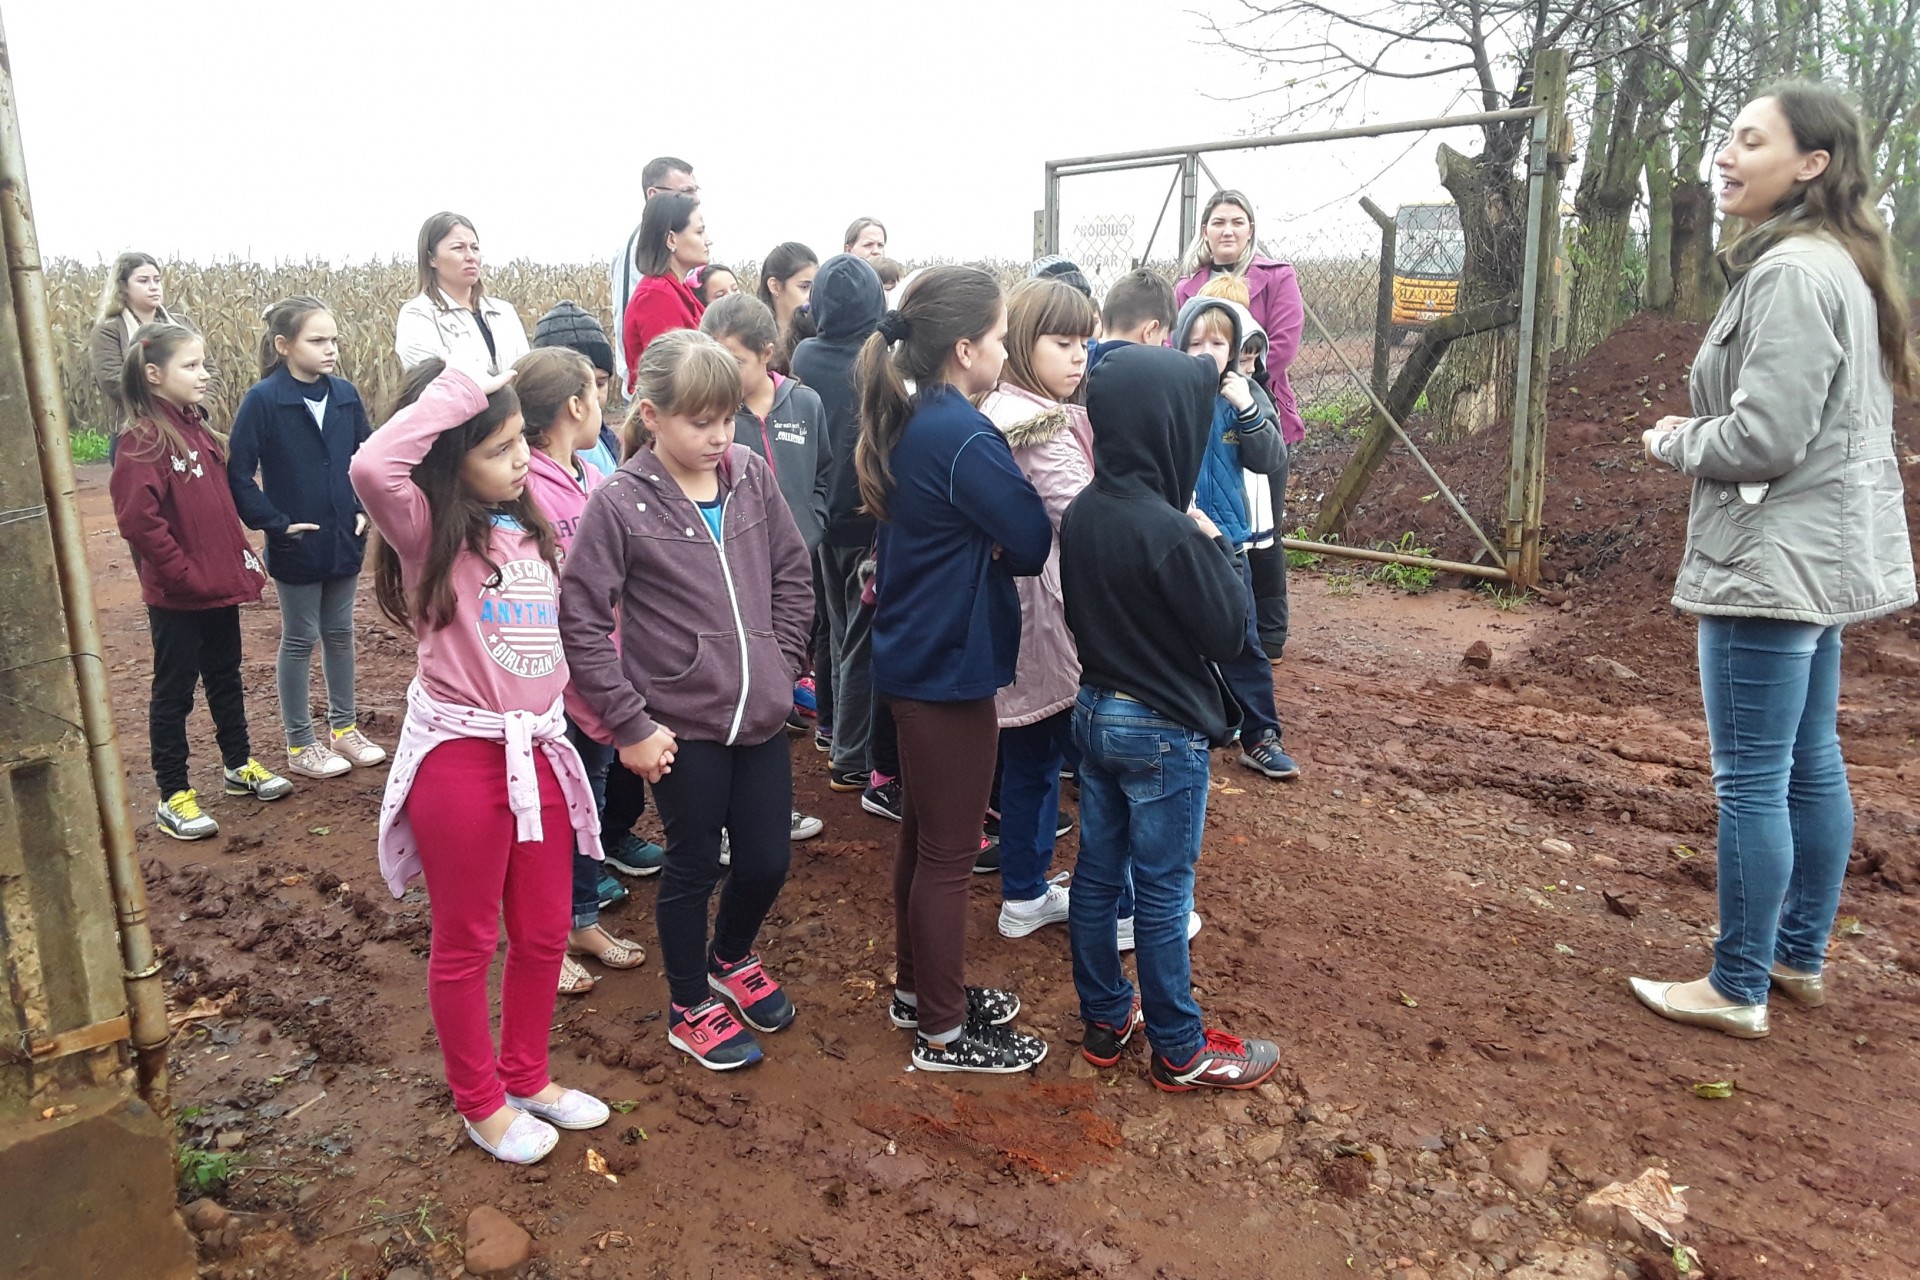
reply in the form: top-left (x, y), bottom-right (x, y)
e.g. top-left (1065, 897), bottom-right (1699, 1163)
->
top-left (1632, 83), bottom-right (1920, 1040)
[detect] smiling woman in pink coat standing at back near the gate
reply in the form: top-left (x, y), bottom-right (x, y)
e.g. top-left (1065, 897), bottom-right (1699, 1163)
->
top-left (1173, 190), bottom-right (1308, 658)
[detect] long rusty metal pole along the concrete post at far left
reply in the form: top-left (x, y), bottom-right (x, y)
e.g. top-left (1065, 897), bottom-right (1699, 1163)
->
top-left (0, 7), bottom-right (169, 1115)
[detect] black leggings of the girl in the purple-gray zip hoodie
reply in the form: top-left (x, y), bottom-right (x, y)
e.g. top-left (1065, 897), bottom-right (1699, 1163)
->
top-left (653, 731), bottom-right (793, 1007)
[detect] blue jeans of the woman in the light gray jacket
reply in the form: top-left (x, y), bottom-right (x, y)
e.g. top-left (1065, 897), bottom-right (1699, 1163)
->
top-left (1699, 618), bottom-right (1853, 1004)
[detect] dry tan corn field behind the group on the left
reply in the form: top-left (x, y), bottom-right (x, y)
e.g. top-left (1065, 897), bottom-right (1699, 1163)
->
top-left (46, 259), bottom-right (1052, 441)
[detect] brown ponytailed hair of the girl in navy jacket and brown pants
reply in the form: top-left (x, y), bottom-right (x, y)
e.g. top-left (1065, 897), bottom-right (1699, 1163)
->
top-left (852, 267), bottom-right (1004, 520)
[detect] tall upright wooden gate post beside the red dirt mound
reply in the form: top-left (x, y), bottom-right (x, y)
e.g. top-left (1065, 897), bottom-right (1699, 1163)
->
top-left (1501, 50), bottom-right (1572, 587)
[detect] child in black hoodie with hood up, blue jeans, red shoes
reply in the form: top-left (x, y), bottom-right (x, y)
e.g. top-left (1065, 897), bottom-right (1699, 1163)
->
top-left (1060, 345), bottom-right (1279, 1092)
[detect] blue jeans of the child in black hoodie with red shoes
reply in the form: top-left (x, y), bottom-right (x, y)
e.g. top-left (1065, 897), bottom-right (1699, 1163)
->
top-left (1068, 685), bottom-right (1210, 1063)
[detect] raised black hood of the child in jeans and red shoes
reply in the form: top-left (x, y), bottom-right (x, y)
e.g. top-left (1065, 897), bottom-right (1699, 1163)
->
top-left (1087, 344), bottom-right (1219, 510)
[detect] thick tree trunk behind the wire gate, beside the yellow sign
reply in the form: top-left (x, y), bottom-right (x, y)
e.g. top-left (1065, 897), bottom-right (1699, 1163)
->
top-left (1427, 142), bottom-right (1526, 439)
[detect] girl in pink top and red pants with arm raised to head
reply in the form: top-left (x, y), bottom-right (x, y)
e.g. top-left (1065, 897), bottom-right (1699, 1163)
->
top-left (349, 359), bottom-right (607, 1165)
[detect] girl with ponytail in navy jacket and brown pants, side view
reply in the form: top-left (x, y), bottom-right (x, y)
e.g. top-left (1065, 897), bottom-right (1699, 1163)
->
top-left (854, 267), bottom-right (1054, 1073)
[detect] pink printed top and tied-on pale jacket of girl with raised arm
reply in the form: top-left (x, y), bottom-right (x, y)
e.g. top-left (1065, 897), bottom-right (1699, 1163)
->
top-left (348, 368), bottom-right (601, 898)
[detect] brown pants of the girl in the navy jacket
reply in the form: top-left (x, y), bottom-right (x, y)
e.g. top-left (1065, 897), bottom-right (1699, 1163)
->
top-left (889, 699), bottom-right (1000, 1036)
